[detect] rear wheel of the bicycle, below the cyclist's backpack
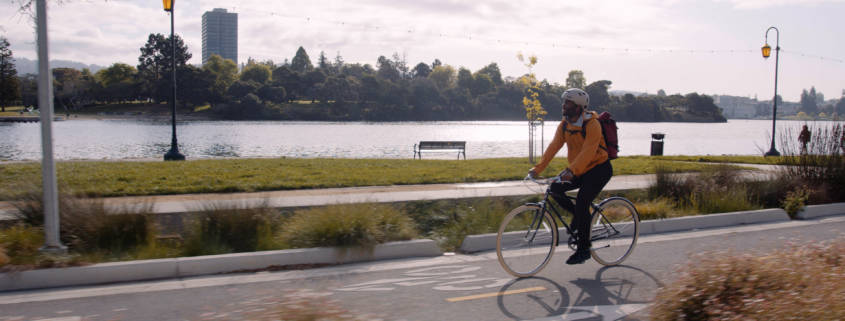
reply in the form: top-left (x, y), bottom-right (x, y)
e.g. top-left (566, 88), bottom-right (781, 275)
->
top-left (590, 197), bottom-right (640, 265)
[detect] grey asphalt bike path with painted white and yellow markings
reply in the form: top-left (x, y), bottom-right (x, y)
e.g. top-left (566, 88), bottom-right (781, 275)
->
top-left (0, 216), bottom-right (845, 320)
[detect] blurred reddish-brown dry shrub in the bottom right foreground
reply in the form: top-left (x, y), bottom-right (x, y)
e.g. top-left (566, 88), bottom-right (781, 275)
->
top-left (651, 239), bottom-right (845, 320)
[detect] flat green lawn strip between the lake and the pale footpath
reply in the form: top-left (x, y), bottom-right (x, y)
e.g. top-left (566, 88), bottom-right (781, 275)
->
top-left (0, 157), bottom-right (748, 200)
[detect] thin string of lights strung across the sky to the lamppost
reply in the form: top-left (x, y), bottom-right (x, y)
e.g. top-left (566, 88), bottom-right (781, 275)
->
top-left (236, 9), bottom-right (845, 63)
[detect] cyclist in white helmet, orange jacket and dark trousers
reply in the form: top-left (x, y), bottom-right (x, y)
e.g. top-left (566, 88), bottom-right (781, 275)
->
top-left (528, 88), bottom-right (613, 264)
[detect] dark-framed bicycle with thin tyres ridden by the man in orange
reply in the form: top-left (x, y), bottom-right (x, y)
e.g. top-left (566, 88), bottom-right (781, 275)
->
top-left (496, 176), bottom-right (640, 277)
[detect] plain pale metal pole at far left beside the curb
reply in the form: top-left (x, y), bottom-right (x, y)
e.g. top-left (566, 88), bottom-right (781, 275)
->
top-left (35, 0), bottom-right (67, 253)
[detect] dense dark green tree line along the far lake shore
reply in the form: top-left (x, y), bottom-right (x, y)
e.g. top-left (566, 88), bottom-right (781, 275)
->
top-left (0, 34), bottom-right (724, 121)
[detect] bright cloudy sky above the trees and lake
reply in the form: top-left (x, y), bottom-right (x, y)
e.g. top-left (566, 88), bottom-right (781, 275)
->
top-left (0, 0), bottom-right (845, 101)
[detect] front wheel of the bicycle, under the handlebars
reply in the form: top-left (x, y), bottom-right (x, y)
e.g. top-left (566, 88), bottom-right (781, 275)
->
top-left (496, 204), bottom-right (558, 278)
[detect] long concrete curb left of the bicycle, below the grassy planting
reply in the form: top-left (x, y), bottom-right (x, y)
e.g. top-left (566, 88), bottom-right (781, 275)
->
top-left (0, 239), bottom-right (443, 291)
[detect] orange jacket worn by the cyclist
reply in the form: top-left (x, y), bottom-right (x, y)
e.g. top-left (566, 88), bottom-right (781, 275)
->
top-left (532, 111), bottom-right (607, 176)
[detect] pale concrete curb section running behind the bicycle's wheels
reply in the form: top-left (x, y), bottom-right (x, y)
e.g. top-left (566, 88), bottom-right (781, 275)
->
top-left (460, 208), bottom-right (788, 253)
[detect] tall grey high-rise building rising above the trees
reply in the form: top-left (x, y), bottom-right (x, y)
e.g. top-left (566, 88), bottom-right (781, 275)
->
top-left (202, 8), bottom-right (238, 64)
